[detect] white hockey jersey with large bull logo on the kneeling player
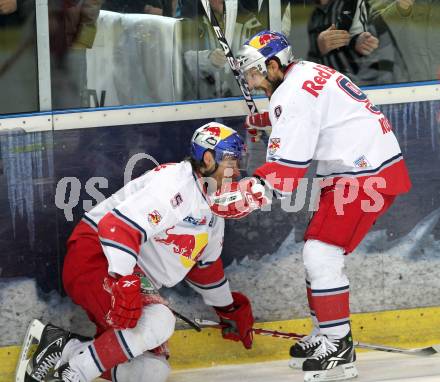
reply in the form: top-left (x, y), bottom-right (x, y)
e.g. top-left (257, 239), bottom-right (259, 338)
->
top-left (83, 161), bottom-right (232, 306)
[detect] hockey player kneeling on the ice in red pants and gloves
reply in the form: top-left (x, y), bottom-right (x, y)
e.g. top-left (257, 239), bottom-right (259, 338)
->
top-left (18, 122), bottom-right (262, 382)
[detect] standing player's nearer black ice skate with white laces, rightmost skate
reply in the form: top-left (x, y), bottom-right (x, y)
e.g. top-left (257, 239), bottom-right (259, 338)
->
top-left (303, 332), bottom-right (358, 382)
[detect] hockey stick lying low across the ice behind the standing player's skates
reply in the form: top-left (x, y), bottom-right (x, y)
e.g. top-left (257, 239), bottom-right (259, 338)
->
top-left (194, 318), bottom-right (440, 357)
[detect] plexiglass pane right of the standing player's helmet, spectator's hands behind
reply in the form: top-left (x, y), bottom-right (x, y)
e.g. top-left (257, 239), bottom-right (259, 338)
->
top-left (290, 0), bottom-right (440, 85)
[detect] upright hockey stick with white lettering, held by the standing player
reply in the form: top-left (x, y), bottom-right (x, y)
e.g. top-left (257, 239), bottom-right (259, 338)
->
top-left (201, 0), bottom-right (268, 141)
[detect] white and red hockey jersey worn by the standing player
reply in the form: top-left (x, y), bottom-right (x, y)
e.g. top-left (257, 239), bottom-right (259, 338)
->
top-left (256, 61), bottom-right (410, 195)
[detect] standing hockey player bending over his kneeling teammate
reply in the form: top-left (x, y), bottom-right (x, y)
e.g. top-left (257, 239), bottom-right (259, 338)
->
top-left (237, 31), bottom-right (411, 381)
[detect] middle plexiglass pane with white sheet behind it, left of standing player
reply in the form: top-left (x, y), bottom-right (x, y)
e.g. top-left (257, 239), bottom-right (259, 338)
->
top-left (49, 0), bottom-right (269, 109)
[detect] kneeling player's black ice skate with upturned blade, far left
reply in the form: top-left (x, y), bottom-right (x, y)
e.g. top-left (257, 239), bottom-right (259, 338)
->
top-left (15, 320), bottom-right (89, 382)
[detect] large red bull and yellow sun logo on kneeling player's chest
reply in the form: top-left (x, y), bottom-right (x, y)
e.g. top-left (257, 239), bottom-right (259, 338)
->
top-left (154, 226), bottom-right (208, 268)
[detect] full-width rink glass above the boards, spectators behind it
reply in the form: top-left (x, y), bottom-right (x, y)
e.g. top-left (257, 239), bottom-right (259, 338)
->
top-left (0, 0), bottom-right (440, 114)
